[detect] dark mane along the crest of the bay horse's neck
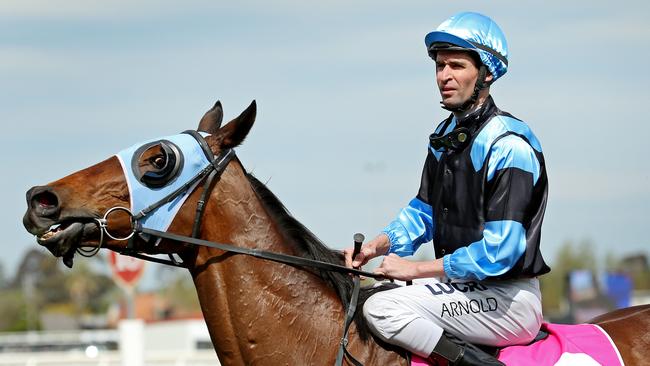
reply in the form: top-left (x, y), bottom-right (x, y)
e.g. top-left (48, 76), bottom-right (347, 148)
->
top-left (246, 173), bottom-right (392, 341)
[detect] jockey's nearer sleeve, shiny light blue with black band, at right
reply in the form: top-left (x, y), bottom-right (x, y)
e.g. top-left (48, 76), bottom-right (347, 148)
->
top-left (443, 135), bottom-right (540, 280)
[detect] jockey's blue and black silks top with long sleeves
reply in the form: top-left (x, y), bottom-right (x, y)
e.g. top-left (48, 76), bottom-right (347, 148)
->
top-left (384, 98), bottom-right (550, 280)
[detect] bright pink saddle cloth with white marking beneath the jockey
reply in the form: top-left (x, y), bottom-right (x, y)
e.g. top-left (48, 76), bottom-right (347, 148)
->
top-left (411, 323), bottom-right (624, 366)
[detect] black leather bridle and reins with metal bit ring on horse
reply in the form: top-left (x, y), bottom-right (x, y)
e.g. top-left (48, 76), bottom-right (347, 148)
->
top-left (83, 130), bottom-right (384, 366)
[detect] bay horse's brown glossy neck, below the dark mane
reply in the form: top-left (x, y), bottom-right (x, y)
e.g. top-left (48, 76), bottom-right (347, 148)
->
top-left (187, 170), bottom-right (343, 365)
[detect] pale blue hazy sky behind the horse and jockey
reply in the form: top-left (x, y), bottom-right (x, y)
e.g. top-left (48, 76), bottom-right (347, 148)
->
top-left (0, 0), bottom-right (650, 284)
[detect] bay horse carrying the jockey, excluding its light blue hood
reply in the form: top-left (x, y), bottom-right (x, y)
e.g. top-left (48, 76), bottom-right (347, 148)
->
top-left (23, 101), bottom-right (650, 365)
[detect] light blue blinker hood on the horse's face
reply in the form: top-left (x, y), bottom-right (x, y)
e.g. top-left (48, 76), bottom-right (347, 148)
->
top-left (115, 133), bottom-right (210, 231)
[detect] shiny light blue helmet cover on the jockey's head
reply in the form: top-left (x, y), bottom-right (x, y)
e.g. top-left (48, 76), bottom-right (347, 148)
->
top-left (424, 12), bottom-right (508, 80)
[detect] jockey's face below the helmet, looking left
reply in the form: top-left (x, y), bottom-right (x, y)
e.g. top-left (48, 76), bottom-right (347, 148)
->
top-left (436, 51), bottom-right (478, 108)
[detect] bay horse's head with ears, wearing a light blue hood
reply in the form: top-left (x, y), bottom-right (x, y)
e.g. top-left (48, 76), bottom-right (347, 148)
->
top-left (23, 102), bottom-right (256, 266)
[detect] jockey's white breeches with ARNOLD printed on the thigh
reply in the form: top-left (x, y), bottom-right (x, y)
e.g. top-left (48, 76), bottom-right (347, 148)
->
top-left (363, 279), bottom-right (542, 358)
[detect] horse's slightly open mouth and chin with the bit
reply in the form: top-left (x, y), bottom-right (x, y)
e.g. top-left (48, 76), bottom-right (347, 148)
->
top-left (36, 221), bottom-right (97, 267)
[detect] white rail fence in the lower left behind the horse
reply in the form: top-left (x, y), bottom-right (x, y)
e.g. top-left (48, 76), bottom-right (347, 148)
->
top-left (0, 319), bottom-right (219, 366)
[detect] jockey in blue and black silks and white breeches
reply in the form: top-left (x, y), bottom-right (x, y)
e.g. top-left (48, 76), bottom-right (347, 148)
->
top-left (344, 12), bottom-right (550, 365)
